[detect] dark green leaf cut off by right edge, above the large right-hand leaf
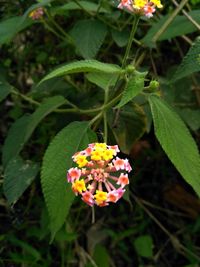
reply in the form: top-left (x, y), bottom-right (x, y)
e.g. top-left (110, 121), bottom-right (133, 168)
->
top-left (171, 37), bottom-right (200, 82)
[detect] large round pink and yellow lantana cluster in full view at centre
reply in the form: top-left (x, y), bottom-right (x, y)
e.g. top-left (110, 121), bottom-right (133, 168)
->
top-left (67, 143), bottom-right (132, 207)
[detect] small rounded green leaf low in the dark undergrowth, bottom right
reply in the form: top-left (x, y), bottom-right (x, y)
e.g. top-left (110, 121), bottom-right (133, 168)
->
top-left (134, 235), bottom-right (153, 258)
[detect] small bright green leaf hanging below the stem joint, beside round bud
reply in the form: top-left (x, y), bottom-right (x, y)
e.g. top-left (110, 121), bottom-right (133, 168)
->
top-left (116, 71), bottom-right (147, 108)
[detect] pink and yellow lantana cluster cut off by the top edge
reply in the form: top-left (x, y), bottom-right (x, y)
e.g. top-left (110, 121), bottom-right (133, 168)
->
top-left (118, 0), bottom-right (163, 18)
